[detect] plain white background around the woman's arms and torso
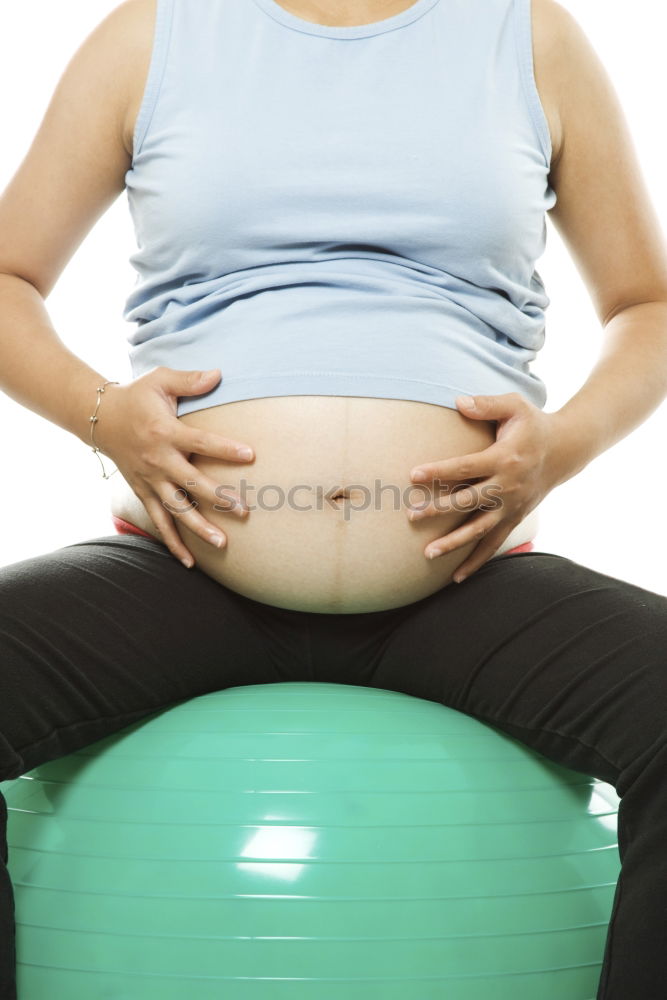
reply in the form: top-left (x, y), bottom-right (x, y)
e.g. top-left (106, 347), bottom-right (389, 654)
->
top-left (0, 0), bottom-right (667, 594)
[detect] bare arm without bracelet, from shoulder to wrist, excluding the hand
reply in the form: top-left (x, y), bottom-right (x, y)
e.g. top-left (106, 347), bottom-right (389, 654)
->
top-left (534, 0), bottom-right (667, 482)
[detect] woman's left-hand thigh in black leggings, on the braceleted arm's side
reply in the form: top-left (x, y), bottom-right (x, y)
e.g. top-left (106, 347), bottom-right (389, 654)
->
top-left (0, 535), bottom-right (307, 780)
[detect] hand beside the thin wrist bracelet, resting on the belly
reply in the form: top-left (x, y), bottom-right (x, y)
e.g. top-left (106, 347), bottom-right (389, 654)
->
top-left (94, 366), bottom-right (254, 568)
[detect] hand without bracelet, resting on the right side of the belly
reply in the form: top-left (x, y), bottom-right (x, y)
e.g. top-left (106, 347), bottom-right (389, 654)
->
top-left (408, 392), bottom-right (567, 583)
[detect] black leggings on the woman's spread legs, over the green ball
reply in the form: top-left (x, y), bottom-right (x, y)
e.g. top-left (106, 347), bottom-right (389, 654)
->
top-left (0, 535), bottom-right (667, 1000)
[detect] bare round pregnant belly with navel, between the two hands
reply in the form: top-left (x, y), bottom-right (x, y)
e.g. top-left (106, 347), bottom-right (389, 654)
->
top-left (112, 396), bottom-right (536, 614)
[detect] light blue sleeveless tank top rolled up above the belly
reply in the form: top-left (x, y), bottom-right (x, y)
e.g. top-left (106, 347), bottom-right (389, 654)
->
top-left (123, 0), bottom-right (556, 416)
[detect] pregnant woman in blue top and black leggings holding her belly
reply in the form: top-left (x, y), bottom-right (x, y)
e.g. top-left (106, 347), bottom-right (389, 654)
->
top-left (0, 0), bottom-right (667, 1000)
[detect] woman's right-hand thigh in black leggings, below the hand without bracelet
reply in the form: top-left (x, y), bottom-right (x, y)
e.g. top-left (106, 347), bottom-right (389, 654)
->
top-left (326, 551), bottom-right (667, 794)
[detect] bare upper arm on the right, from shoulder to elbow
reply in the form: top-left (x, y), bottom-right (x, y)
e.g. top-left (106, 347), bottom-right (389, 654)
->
top-left (531, 0), bottom-right (667, 325)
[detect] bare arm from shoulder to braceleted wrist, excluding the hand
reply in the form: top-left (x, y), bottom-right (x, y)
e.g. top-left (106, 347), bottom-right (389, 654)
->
top-left (0, 0), bottom-right (153, 443)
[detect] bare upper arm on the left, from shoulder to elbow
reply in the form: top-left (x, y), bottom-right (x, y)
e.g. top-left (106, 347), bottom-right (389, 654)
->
top-left (0, 0), bottom-right (156, 297)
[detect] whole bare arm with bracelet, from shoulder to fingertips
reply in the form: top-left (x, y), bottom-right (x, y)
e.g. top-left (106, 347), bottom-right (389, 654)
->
top-left (0, 0), bottom-right (252, 565)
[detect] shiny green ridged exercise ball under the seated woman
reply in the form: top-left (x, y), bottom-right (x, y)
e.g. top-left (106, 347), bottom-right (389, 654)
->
top-left (0, 681), bottom-right (620, 1000)
